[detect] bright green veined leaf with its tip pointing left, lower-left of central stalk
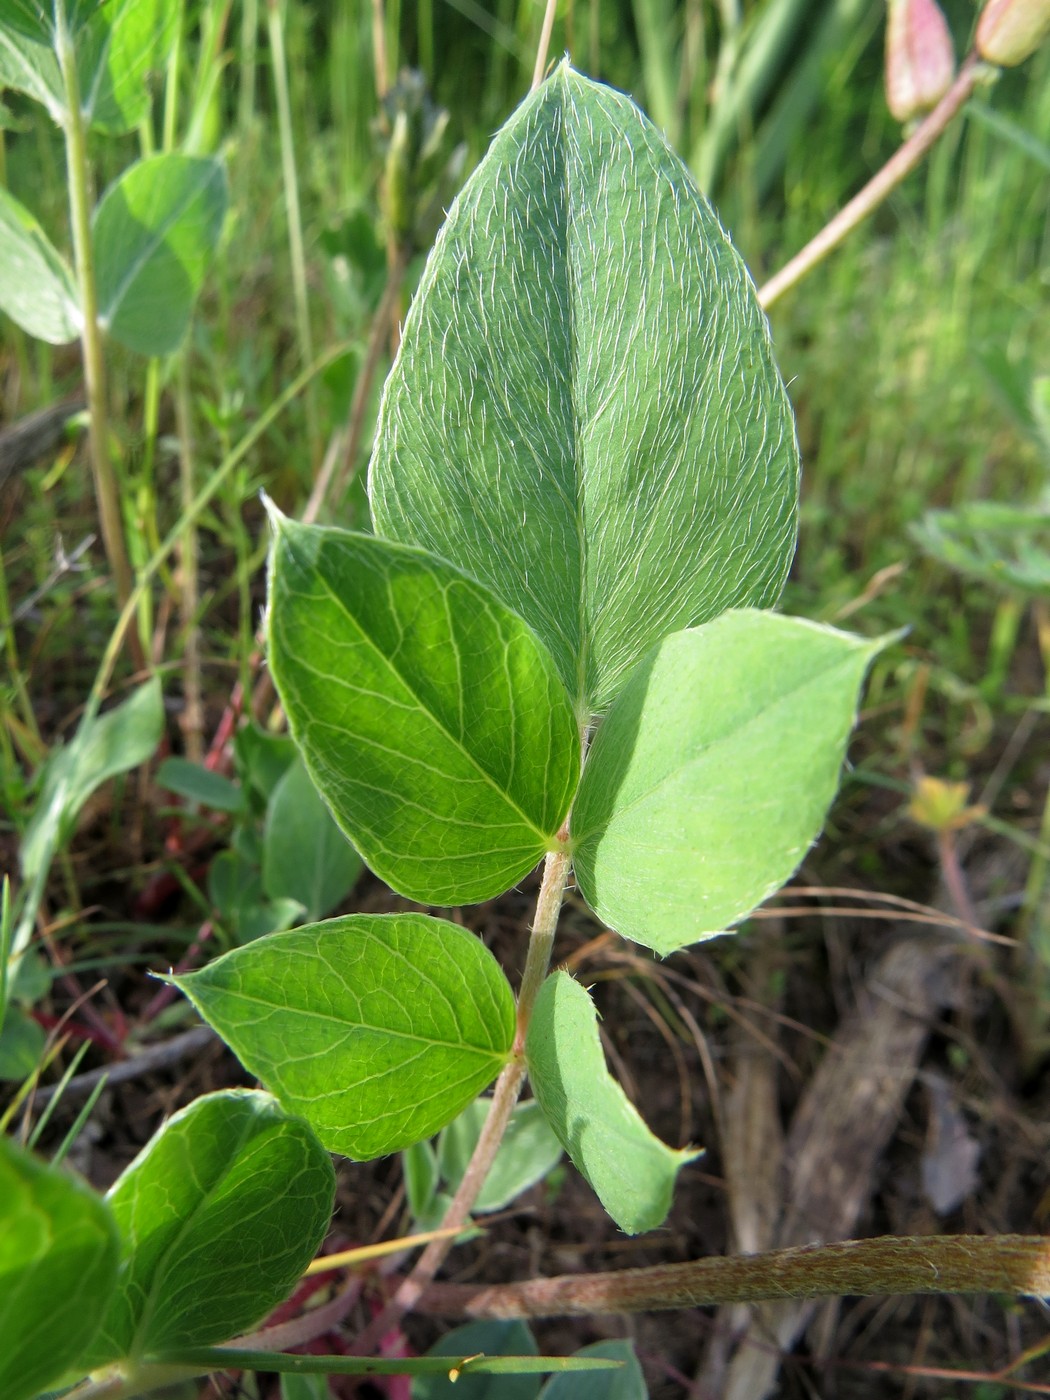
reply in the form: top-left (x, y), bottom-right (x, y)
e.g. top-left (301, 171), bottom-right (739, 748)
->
top-left (171, 914), bottom-right (514, 1161)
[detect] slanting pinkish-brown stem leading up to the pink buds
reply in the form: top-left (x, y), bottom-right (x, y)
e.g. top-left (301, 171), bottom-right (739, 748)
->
top-left (759, 53), bottom-right (987, 309)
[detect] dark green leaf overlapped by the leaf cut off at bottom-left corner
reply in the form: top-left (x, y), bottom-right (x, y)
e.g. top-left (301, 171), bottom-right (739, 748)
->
top-left (90, 1089), bottom-right (336, 1368)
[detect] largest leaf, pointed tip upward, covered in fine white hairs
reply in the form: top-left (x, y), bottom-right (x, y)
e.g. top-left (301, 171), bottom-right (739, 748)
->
top-left (370, 64), bottom-right (798, 717)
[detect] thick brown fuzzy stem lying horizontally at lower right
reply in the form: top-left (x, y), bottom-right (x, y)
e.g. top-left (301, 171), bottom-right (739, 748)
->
top-left (417, 1235), bottom-right (1050, 1317)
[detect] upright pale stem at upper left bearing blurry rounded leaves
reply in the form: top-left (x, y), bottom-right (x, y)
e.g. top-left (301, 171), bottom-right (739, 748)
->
top-left (55, 0), bottom-right (146, 666)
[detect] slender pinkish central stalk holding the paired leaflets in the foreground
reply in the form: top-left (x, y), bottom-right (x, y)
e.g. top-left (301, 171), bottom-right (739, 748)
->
top-left (354, 850), bottom-right (570, 1352)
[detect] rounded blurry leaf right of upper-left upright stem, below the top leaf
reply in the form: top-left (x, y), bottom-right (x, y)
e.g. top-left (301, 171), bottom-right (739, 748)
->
top-left (94, 154), bottom-right (227, 356)
